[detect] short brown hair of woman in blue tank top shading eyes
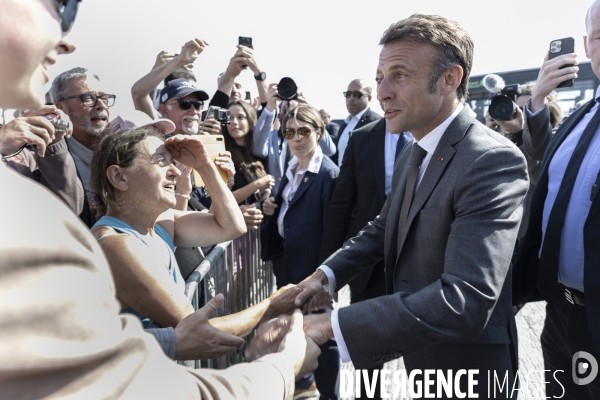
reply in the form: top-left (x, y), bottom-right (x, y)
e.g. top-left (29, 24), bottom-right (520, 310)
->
top-left (90, 127), bottom-right (164, 218)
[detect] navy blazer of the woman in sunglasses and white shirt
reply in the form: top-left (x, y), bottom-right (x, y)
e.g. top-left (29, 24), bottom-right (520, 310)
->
top-left (262, 156), bottom-right (340, 283)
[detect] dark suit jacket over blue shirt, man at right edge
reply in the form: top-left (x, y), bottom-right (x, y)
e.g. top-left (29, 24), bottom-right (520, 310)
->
top-left (513, 100), bottom-right (600, 349)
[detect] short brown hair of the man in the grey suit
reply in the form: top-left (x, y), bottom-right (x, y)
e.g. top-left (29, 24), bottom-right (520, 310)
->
top-left (379, 14), bottom-right (473, 100)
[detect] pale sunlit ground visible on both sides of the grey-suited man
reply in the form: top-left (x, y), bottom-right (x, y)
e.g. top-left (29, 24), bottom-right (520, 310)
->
top-left (332, 286), bottom-right (546, 400)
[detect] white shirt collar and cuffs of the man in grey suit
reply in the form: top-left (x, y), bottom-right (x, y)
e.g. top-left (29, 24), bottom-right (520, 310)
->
top-left (317, 103), bottom-right (464, 362)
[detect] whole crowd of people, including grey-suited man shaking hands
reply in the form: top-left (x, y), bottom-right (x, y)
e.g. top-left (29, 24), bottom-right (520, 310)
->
top-left (0, 0), bottom-right (600, 399)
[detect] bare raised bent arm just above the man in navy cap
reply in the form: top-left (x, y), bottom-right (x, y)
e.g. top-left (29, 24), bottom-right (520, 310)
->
top-left (131, 39), bottom-right (208, 119)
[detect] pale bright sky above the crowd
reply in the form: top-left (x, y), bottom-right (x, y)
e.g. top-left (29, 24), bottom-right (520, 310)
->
top-left (34, 0), bottom-right (591, 119)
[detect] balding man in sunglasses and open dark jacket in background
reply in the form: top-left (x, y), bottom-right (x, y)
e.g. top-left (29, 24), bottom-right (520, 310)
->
top-left (330, 79), bottom-right (382, 167)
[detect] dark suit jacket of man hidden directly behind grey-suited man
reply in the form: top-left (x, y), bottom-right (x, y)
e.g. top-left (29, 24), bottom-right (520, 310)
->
top-left (320, 118), bottom-right (406, 296)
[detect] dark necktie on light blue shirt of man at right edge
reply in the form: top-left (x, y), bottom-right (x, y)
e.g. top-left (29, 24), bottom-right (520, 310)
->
top-left (538, 99), bottom-right (600, 298)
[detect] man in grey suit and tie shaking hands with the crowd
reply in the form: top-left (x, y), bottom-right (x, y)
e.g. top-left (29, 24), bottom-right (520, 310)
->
top-left (296, 14), bottom-right (528, 398)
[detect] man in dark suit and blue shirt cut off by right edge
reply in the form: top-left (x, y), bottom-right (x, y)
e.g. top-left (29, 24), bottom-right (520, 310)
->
top-left (513, 0), bottom-right (600, 400)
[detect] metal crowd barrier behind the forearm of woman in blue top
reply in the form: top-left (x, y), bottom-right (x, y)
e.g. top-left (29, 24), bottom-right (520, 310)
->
top-left (180, 230), bottom-right (275, 368)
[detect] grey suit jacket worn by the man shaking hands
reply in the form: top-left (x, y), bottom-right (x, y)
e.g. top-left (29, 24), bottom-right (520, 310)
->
top-left (324, 106), bottom-right (529, 368)
